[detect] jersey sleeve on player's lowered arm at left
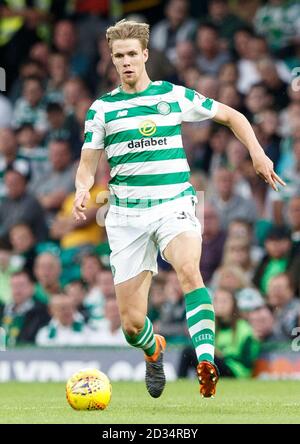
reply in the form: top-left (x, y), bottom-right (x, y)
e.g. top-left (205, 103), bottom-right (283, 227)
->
top-left (82, 100), bottom-right (105, 150)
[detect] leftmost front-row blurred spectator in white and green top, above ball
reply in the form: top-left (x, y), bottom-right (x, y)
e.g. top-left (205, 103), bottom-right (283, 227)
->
top-left (36, 293), bottom-right (93, 347)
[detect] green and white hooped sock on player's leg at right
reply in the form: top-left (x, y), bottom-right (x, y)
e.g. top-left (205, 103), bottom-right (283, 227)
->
top-left (185, 287), bottom-right (215, 362)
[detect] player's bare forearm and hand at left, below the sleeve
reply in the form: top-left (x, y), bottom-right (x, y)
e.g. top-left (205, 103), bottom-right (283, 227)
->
top-left (73, 148), bottom-right (103, 221)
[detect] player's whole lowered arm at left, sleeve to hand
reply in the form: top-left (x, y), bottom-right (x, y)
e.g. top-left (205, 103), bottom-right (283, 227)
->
top-left (72, 100), bottom-right (105, 221)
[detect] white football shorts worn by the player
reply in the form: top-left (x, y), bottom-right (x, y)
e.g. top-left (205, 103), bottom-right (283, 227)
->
top-left (105, 196), bottom-right (201, 284)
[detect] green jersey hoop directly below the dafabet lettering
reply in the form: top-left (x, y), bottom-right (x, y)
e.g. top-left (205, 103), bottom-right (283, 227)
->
top-left (108, 148), bottom-right (186, 168)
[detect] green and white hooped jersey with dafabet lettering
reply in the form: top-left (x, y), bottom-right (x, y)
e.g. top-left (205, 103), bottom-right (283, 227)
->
top-left (82, 81), bottom-right (217, 208)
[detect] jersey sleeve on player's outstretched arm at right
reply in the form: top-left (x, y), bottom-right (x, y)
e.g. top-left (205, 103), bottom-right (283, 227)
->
top-left (176, 86), bottom-right (218, 122)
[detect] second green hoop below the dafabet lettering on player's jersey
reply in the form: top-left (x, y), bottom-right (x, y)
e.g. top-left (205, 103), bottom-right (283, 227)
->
top-left (109, 171), bottom-right (190, 187)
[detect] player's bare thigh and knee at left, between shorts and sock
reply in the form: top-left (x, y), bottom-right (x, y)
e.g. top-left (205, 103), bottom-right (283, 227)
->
top-left (115, 270), bottom-right (152, 324)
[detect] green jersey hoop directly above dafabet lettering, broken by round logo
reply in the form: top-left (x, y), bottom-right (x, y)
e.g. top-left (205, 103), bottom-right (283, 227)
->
top-left (104, 125), bottom-right (181, 148)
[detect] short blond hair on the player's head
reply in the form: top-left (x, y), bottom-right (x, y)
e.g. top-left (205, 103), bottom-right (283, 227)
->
top-left (106, 19), bottom-right (149, 49)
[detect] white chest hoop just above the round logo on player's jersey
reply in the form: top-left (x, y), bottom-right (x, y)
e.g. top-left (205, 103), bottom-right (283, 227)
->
top-left (105, 112), bottom-right (181, 137)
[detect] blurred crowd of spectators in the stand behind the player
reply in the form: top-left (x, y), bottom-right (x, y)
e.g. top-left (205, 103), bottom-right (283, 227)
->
top-left (0, 0), bottom-right (300, 377)
